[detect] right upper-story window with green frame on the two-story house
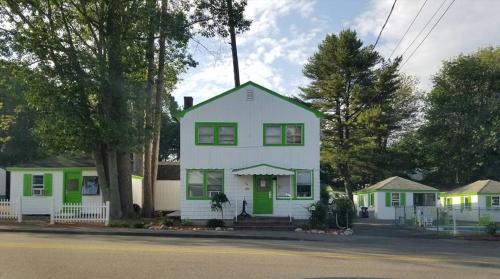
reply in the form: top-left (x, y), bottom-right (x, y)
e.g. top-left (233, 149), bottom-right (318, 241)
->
top-left (264, 123), bottom-right (304, 146)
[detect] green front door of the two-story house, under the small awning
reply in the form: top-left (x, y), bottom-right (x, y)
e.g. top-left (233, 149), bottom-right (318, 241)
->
top-left (253, 175), bottom-right (273, 214)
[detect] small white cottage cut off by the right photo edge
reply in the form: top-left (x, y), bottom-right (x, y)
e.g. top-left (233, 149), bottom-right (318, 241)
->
top-left (440, 180), bottom-right (500, 222)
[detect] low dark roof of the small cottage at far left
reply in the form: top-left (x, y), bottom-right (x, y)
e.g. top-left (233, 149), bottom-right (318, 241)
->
top-left (7, 155), bottom-right (95, 170)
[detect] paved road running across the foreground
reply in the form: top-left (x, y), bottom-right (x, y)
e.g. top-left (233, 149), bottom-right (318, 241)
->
top-left (0, 233), bottom-right (500, 279)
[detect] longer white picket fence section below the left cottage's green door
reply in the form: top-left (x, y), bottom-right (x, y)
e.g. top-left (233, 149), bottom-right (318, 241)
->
top-left (50, 201), bottom-right (109, 226)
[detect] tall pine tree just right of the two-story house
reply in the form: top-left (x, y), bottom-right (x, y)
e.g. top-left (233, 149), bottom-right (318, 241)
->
top-left (302, 30), bottom-right (414, 199)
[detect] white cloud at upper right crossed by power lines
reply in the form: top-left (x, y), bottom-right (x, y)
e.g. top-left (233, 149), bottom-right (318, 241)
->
top-left (351, 0), bottom-right (500, 89)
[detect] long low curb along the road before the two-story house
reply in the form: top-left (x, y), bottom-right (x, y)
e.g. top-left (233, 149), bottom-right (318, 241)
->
top-left (0, 228), bottom-right (308, 241)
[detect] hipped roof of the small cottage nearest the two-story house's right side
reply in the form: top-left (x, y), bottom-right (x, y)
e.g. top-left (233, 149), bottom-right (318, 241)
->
top-left (357, 176), bottom-right (439, 193)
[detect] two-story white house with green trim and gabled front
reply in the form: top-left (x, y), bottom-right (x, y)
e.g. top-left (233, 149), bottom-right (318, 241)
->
top-left (178, 82), bottom-right (322, 225)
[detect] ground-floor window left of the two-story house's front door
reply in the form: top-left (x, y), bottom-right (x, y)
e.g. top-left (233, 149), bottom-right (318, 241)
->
top-left (187, 170), bottom-right (224, 199)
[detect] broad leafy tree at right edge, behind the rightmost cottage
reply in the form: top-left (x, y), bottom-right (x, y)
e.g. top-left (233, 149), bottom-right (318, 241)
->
top-left (413, 48), bottom-right (500, 187)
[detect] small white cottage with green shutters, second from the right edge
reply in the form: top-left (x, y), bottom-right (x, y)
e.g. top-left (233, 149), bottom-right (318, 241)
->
top-left (354, 176), bottom-right (438, 220)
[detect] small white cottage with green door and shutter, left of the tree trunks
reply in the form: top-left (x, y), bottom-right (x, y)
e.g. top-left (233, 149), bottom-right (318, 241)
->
top-left (7, 156), bottom-right (142, 215)
